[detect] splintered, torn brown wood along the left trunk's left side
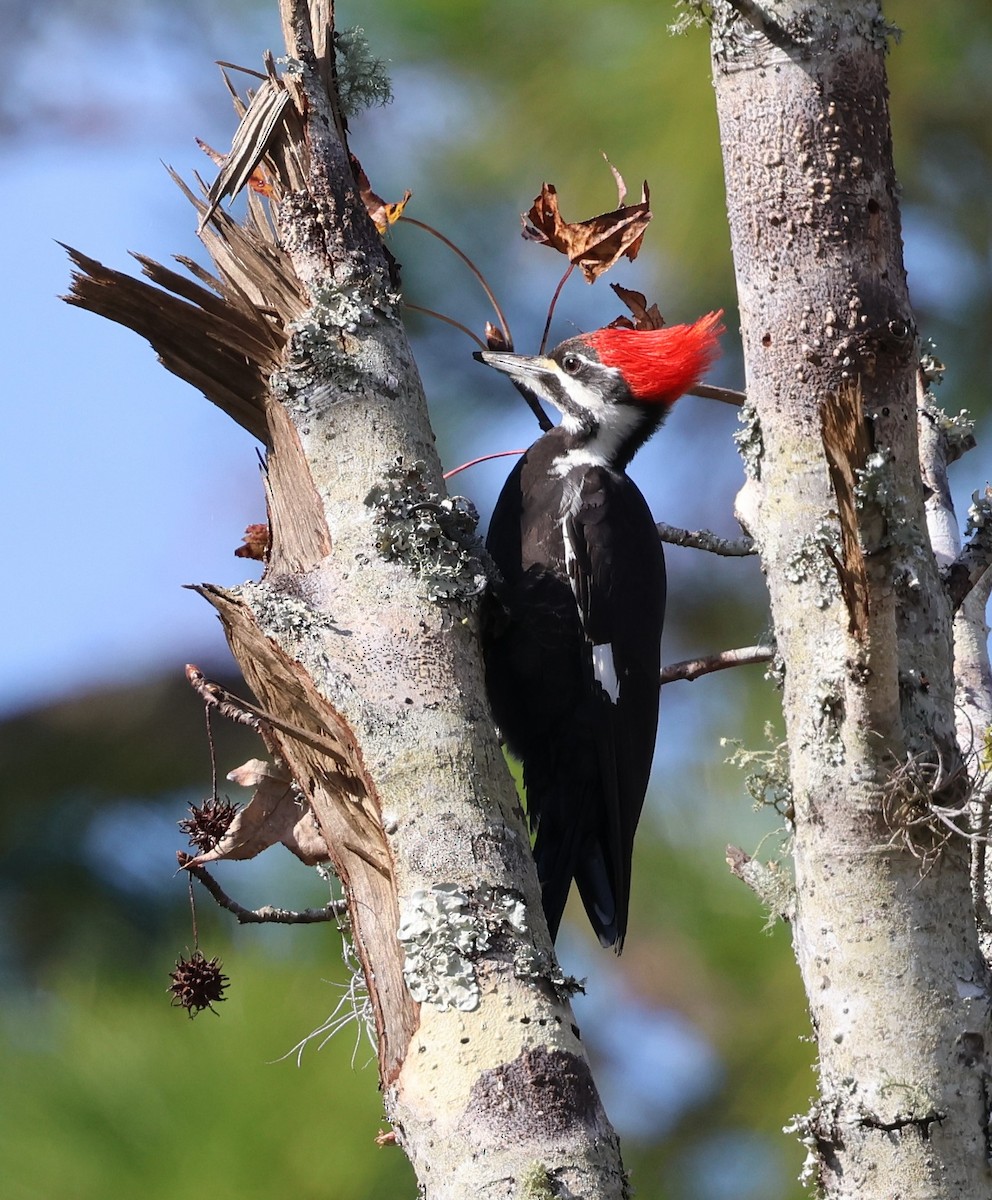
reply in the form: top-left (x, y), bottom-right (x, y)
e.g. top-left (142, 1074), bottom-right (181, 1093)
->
top-left (66, 0), bottom-right (420, 1086)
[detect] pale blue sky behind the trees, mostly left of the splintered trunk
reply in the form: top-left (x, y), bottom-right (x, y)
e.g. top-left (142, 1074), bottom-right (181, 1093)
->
top-left (0, 7), bottom-right (990, 712)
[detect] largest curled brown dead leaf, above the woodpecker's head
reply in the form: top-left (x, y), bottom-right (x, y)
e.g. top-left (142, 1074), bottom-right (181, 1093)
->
top-left (521, 163), bottom-right (651, 283)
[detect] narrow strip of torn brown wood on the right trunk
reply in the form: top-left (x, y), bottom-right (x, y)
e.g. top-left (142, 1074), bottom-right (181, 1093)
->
top-left (820, 385), bottom-right (874, 642)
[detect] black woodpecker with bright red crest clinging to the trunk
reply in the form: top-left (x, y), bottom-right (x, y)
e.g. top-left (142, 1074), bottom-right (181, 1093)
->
top-left (475, 312), bottom-right (722, 953)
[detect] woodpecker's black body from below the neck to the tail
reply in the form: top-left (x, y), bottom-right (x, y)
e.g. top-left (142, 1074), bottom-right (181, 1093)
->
top-left (483, 426), bottom-right (665, 949)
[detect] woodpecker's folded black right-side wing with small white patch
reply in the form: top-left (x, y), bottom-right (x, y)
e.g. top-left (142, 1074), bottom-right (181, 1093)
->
top-left (561, 467), bottom-right (665, 948)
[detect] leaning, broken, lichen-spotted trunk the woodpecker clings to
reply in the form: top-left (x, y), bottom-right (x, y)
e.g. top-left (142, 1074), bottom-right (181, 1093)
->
top-left (60, 0), bottom-right (626, 1200)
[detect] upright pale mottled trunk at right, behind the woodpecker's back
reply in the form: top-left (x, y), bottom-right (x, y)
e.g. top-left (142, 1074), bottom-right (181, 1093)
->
top-left (713, 0), bottom-right (992, 1200)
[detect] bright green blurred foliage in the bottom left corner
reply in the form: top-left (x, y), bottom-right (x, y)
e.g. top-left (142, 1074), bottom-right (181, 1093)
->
top-left (0, 950), bottom-right (415, 1200)
